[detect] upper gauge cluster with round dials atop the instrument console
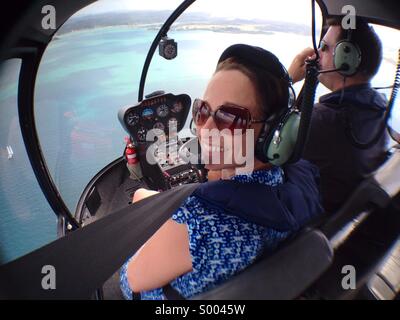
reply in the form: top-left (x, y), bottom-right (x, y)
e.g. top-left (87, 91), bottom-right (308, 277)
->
top-left (118, 93), bottom-right (191, 144)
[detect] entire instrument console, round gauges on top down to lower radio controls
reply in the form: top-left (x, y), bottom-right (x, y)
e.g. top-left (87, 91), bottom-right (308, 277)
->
top-left (118, 91), bottom-right (202, 190)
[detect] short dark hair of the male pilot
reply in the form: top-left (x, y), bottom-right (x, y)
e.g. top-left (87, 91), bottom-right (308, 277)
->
top-left (327, 18), bottom-right (382, 80)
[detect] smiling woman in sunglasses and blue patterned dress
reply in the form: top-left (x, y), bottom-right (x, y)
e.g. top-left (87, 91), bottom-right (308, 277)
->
top-left (121, 45), bottom-right (322, 299)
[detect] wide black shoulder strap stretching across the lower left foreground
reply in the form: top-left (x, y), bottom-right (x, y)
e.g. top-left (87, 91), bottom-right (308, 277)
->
top-left (0, 184), bottom-right (198, 299)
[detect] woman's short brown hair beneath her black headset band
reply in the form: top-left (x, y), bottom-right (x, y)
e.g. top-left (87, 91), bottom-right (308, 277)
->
top-left (215, 57), bottom-right (289, 119)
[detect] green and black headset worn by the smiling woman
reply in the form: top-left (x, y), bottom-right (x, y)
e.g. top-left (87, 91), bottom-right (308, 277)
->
top-left (218, 44), bottom-right (300, 166)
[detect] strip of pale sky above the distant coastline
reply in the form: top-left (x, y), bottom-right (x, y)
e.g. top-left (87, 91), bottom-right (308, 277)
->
top-left (78, 0), bottom-right (320, 24)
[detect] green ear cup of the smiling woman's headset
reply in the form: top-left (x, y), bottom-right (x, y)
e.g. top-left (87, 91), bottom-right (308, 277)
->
top-left (264, 111), bottom-right (300, 166)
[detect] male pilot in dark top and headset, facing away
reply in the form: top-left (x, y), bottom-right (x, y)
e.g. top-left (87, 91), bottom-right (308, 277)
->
top-left (288, 19), bottom-right (387, 213)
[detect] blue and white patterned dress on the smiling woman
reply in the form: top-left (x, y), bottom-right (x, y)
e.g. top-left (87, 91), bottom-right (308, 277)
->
top-left (120, 167), bottom-right (289, 300)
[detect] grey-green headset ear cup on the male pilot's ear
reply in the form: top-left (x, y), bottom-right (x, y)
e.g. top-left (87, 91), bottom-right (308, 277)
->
top-left (333, 40), bottom-right (361, 76)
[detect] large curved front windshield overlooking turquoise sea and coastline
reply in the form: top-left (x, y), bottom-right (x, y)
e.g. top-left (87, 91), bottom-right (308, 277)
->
top-left (31, 0), bottom-right (399, 238)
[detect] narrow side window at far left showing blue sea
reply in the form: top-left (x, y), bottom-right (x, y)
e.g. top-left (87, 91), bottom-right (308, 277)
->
top-left (0, 59), bottom-right (57, 264)
